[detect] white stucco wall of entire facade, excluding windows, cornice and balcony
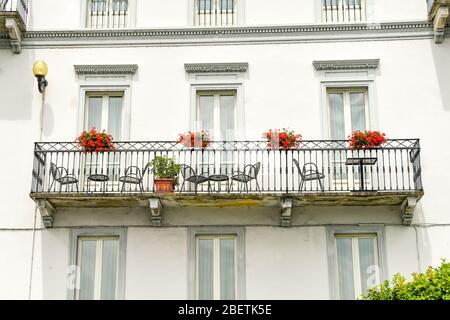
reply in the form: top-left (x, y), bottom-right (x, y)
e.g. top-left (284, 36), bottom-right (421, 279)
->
top-left (0, 0), bottom-right (450, 299)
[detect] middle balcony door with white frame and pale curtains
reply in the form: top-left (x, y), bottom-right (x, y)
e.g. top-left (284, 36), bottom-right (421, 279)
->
top-left (196, 90), bottom-right (237, 179)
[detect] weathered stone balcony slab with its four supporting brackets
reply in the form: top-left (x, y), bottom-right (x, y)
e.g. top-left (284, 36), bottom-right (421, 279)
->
top-left (30, 190), bottom-right (424, 227)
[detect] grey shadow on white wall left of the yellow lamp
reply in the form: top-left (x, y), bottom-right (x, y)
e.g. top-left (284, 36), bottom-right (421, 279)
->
top-left (0, 50), bottom-right (36, 121)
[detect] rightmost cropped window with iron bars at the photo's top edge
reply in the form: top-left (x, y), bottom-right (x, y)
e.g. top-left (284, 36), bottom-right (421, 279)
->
top-left (322, 0), bottom-right (366, 23)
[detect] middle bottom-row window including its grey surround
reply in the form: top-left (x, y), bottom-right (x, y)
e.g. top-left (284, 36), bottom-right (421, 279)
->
top-left (188, 227), bottom-right (245, 300)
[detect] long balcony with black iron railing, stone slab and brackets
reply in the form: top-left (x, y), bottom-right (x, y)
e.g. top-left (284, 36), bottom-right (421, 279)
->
top-left (30, 139), bottom-right (423, 226)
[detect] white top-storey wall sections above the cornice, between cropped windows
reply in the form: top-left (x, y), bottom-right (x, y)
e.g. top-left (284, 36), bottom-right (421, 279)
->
top-left (28, 0), bottom-right (427, 30)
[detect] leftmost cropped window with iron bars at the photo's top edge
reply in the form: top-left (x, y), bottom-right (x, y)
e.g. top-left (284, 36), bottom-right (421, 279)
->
top-left (86, 0), bottom-right (129, 29)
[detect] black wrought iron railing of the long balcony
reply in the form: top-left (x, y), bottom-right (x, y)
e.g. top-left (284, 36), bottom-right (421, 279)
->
top-left (32, 139), bottom-right (422, 194)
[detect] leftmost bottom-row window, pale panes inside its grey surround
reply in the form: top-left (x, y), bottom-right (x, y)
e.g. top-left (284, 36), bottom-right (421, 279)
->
top-left (75, 236), bottom-right (119, 300)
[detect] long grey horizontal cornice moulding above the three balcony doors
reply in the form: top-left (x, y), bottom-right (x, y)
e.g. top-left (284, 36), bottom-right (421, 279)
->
top-left (0, 21), bottom-right (434, 48)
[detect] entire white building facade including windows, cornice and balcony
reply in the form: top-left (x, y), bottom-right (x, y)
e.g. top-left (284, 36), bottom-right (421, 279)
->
top-left (0, 0), bottom-right (450, 299)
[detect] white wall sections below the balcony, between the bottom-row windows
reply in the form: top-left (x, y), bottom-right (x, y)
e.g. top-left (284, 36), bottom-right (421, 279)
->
top-left (12, 222), bottom-right (430, 300)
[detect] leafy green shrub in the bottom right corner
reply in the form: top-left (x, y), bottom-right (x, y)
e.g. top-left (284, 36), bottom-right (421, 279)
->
top-left (362, 260), bottom-right (450, 300)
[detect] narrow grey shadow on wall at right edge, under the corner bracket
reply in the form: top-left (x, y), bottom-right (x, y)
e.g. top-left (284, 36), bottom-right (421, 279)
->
top-left (431, 36), bottom-right (450, 111)
